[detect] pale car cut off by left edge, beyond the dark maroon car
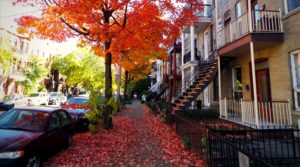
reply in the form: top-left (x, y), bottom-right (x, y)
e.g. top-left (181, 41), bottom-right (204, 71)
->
top-left (0, 95), bottom-right (28, 111)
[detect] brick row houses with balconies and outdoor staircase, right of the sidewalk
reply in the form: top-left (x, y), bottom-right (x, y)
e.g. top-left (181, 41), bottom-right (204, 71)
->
top-left (149, 0), bottom-right (300, 128)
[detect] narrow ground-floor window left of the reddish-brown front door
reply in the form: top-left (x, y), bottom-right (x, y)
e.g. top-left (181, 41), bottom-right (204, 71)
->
top-left (232, 67), bottom-right (243, 99)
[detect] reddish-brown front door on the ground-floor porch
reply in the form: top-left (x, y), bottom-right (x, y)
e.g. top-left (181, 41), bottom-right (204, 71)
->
top-left (256, 69), bottom-right (273, 122)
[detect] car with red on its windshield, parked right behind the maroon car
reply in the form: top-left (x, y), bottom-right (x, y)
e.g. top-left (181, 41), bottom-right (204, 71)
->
top-left (61, 97), bottom-right (90, 130)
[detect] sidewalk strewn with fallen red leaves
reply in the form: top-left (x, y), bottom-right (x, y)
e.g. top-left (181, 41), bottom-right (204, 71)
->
top-left (44, 101), bottom-right (205, 167)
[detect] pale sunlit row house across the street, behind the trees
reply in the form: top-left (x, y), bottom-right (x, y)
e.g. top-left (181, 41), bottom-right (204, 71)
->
top-left (0, 28), bottom-right (62, 99)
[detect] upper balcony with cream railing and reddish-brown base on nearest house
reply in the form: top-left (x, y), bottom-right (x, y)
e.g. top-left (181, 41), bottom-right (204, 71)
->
top-left (217, 10), bottom-right (283, 56)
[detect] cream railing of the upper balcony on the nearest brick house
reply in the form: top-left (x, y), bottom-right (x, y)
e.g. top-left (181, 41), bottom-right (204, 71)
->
top-left (217, 10), bottom-right (283, 48)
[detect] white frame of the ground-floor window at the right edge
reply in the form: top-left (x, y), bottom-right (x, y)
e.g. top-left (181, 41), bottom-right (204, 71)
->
top-left (290, 49), bottom-right (300, 111)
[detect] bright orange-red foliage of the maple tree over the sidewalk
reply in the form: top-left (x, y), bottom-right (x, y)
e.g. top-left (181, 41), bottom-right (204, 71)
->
top-left (14, 0), bottom-right (202, 70)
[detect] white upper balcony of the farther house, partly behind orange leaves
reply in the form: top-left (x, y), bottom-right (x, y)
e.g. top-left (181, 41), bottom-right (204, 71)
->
top-left (183, 4), bottom-right (211, 33)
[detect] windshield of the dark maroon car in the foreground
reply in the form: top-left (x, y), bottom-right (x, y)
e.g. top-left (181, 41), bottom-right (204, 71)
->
top-left (0, 109), bottom-right (49, 131)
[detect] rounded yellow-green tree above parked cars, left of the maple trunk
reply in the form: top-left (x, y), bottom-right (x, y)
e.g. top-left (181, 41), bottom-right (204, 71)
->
top-left (51, 49), bottom-right (105, 92)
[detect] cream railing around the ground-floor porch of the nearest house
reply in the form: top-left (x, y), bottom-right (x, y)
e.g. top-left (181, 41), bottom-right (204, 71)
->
top-left (220, 98), bottom-right (292, 126)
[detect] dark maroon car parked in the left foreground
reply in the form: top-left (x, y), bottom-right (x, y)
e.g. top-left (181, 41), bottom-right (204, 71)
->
top-left (0, 107), bottom-right (74, 167)
